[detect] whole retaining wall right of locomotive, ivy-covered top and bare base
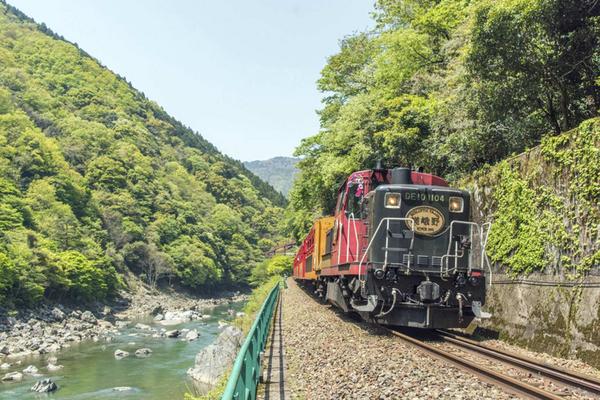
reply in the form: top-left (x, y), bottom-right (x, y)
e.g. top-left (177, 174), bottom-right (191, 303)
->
top-left (457, 118), bottom-right (600, 367)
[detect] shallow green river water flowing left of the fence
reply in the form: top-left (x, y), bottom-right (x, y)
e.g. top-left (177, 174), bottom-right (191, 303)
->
top-left (0, 302), bottom-right (243, 400)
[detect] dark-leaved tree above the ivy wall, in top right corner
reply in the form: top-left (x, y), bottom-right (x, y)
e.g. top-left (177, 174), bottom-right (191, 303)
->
top-left (467, 0), bottom-right (600, 135)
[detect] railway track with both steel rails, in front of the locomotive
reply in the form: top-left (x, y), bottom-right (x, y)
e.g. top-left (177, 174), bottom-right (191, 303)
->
top-left (382, 327), bottom-right (600, 400)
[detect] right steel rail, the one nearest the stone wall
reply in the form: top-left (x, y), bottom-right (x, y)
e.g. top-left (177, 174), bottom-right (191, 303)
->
top-left (436, 330), bottom-right (600, 395)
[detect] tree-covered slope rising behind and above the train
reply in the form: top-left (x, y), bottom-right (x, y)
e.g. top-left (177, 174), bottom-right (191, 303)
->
top-left (288, 0), bottom-right (600, 237)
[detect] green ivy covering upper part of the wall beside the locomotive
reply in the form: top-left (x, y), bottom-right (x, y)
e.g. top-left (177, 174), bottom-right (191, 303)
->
top-left (465, 118), bottom-right (600, 278)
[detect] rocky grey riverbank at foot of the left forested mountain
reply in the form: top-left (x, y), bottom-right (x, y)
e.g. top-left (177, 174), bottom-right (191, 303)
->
top-left (0, 284), bottom-right (247, 368)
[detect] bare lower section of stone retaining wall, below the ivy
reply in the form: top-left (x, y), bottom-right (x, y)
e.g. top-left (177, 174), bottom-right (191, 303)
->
top-left (481, 274), bottom-right (600, 368)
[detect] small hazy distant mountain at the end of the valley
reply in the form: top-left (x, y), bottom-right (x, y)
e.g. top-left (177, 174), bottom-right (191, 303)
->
top-left (244, 157), bottom-right (299, 196)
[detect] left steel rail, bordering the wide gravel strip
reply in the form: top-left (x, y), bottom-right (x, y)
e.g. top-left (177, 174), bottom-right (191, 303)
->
top-left (380, 325), bottom-right (563, 400)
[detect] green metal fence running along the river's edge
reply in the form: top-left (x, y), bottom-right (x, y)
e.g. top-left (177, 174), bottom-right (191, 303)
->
top-left (221, 283), bottom-right (281, 400)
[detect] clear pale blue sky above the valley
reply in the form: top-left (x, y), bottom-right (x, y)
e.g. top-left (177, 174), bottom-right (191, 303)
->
top-left (9, 0), bottom-right (373, 161)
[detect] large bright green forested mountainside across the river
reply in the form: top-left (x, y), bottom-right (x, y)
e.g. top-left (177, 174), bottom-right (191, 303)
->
top-left (0, 2), bottom-right (285, 305)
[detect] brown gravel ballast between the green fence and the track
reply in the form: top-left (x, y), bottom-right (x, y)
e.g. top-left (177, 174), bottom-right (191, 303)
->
top-left (283, 279), bottom-right (515, 400)
